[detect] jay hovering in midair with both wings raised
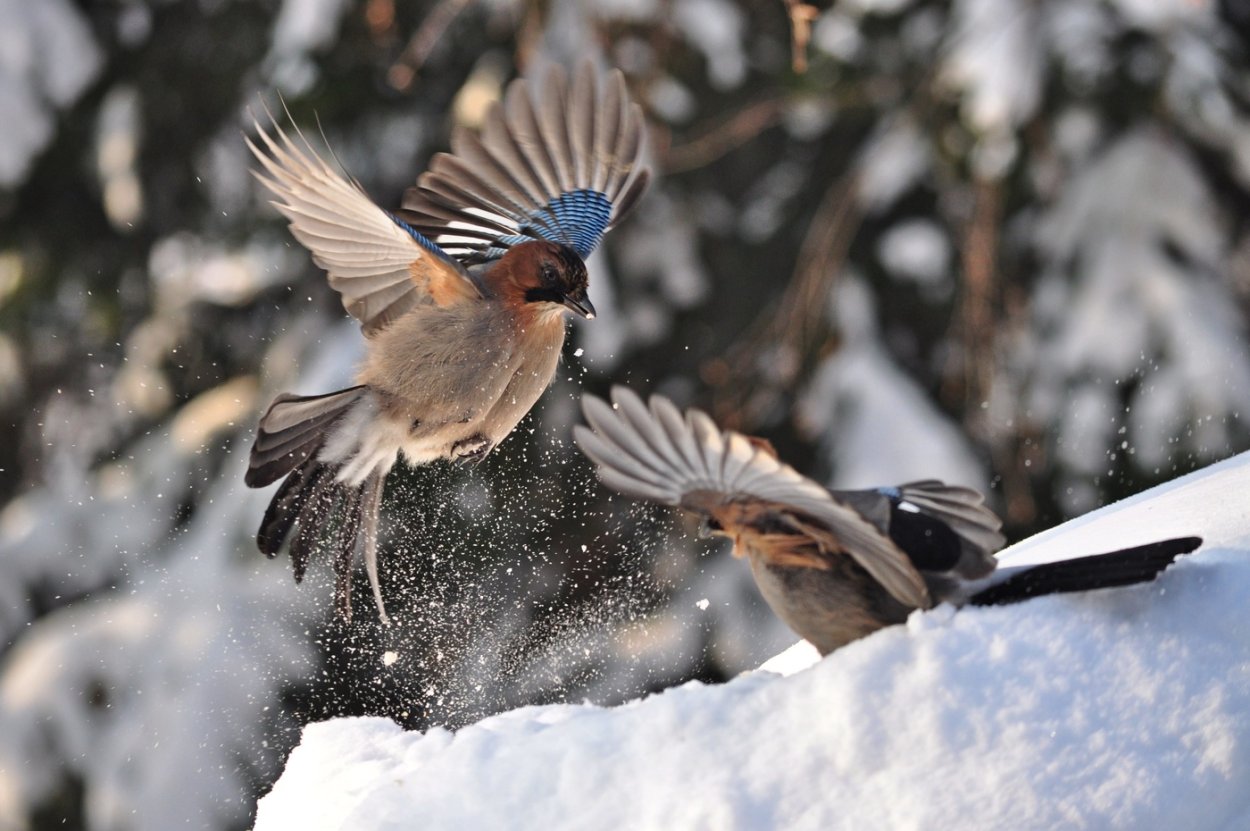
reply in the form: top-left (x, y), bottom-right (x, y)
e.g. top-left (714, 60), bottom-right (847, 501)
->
top-left (245, 64), bottom-right (649, 622)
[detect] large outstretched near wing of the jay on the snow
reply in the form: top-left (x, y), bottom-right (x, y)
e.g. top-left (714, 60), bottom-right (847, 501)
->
top-left (574, 386), bottom-right (930, 609)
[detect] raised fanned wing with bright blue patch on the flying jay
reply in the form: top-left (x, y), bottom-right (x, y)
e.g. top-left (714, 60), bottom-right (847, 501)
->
top-left (401, 61), bottom-right (650, 262)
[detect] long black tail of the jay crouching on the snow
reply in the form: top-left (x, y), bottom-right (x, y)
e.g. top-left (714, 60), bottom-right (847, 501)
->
top-left (968, 536), bottom-right (1203, 606)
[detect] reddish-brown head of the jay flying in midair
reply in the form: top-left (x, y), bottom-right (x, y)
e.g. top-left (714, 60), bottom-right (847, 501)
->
top-left (493, 241), bottom-right (595, 320)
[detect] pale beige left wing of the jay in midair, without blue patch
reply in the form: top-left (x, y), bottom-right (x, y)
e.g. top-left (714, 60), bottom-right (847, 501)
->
top-left (248, 111), bottom-right (481, 335)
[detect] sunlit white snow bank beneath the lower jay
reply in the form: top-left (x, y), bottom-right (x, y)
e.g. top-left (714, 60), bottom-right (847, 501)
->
top-left (256, 454), bottom-right (1250, 831)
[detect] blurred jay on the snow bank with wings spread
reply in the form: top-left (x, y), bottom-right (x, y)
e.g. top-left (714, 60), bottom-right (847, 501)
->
top-left (574, 386), bottom-right (1201, 655)
